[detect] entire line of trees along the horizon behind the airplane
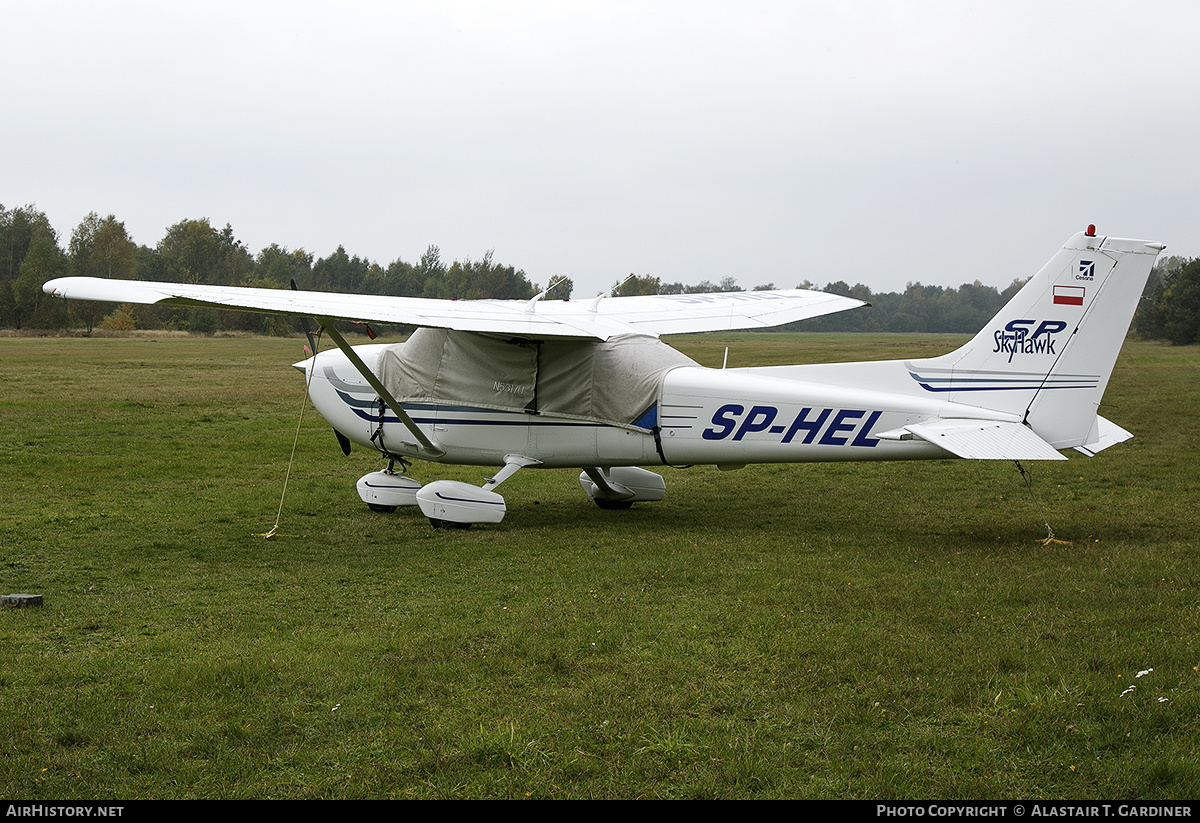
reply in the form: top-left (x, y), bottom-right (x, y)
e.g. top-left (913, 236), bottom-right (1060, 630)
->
top-left (0, 205), bottom-right (1200, 343)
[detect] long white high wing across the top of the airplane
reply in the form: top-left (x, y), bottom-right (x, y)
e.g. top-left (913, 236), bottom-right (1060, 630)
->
top-left (42, 277), bottom-right (866, 341)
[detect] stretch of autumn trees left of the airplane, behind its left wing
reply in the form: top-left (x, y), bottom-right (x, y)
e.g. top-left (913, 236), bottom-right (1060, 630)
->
top-left (0, 205), bottom-right (559, 335)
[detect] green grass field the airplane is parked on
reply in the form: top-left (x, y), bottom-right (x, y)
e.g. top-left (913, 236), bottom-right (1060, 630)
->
top-left (0, 335), bottom-right (1200, 799)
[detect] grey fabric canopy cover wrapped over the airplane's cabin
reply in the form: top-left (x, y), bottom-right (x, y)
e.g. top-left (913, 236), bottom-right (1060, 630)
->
top-left (377, 329), bottom-right (698, 431)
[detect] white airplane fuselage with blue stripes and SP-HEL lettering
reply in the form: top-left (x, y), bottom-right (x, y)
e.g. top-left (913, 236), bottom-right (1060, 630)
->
top-left (306, 344), bottom-right (996, 468)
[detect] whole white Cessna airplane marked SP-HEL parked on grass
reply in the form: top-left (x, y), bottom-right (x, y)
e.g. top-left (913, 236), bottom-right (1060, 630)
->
top-left (43, 227), bottom-right (1164, 528)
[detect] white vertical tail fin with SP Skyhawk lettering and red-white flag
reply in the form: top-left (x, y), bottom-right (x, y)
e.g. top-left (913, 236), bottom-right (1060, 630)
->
top-left (905, 229), bottom-right (1164, 449)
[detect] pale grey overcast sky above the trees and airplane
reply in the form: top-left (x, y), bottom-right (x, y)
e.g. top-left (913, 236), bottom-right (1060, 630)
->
top-left (0, 0), bottom-right (1200, 296)
